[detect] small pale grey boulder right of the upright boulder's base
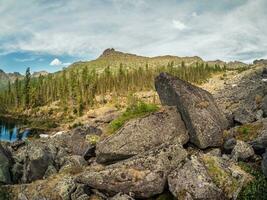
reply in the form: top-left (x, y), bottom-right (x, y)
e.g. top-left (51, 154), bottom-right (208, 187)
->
top-left (231, 140), bottom-right (254, 161)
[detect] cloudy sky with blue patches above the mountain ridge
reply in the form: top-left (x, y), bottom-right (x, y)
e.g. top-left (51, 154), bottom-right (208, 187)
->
top-left (0, 0), bottom-right (267, 73)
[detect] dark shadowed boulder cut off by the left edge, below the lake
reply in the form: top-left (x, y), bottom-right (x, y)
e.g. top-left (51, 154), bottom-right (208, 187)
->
top-left (0, 144), bottom-right (11, 185)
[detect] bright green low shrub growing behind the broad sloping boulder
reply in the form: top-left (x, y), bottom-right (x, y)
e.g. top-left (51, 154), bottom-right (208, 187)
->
top-left (108, 101), bottom-right (159, 134)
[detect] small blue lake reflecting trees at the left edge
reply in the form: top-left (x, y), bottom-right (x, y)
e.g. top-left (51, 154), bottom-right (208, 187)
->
top-left (0, 118), bottom-right (29, 142)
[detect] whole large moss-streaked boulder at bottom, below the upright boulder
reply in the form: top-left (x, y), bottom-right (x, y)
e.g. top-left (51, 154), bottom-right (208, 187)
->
top-left (168, 154), bottom-right (252, 200)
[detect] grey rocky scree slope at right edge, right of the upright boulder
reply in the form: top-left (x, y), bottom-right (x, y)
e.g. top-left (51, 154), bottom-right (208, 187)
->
top-left (214, 67), bottom-right (267, 124)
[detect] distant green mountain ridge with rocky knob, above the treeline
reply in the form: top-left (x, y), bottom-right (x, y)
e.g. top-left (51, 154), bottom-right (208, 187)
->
top-left (67, 48), bottom-right (248, 74)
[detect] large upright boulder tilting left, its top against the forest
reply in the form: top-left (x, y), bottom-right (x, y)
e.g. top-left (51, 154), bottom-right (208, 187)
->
top-left (155, 73), bottom-right (228, 149)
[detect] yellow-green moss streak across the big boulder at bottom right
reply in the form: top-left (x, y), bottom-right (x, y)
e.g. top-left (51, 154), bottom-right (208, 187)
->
top-left (203, 156), bottom-right (239, 196)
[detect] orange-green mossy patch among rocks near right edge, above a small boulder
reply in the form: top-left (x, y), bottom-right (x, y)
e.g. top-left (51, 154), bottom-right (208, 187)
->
top-left (236, 123), bottom-right (263, 142)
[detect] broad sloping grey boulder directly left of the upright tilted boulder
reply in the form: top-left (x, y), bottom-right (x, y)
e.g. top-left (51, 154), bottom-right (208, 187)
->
top-left (96, 107), bottom-right (189, 163)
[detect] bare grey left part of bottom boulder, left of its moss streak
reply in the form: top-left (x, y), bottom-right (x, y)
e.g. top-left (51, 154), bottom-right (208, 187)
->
top-left (168, 156), bottom-right (223, 200)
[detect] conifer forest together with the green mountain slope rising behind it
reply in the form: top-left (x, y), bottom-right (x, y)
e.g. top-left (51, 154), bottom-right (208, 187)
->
top-left (0, 49), bottom-right (247, 122)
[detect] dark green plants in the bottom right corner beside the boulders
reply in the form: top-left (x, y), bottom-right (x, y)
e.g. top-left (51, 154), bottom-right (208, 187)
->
top-left (238, 162), bottom-right (267, 200)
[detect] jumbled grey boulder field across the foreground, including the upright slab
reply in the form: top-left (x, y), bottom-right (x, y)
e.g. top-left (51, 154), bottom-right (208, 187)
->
top-left (0, 67), bottom-right (267, 200)
